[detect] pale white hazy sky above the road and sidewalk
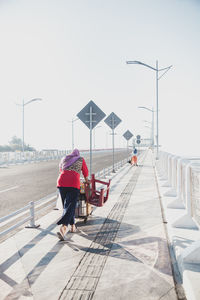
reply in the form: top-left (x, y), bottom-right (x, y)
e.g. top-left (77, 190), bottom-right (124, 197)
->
top-left (0, 0), bottom-right (200, 155)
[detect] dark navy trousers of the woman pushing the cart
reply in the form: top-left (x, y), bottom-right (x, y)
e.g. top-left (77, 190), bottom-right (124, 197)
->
top-left (57, 187), bottom-right (79, 226)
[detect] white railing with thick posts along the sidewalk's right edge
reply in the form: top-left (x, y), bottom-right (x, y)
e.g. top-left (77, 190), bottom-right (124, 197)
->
top-left (156, 152), bottom-right (200, 263)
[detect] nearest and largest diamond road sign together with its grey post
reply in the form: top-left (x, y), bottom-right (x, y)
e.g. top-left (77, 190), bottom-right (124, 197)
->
top-left (77, 100), bottom-right (105, 177)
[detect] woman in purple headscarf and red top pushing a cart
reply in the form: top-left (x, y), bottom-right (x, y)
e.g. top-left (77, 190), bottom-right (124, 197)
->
top-left (57, 149), bottom-right (89, 241)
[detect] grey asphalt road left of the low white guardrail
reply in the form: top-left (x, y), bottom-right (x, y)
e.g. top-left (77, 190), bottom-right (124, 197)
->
top-left (0, 150), bottom-right (130, 217)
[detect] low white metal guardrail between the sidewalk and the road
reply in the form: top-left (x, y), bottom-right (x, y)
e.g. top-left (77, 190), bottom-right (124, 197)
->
top-left (0, 158), bottom-right (130, 238)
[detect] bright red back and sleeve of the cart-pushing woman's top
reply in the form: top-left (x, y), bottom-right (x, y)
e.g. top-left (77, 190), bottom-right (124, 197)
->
top-left (57, 158), bottom-right (88, 189)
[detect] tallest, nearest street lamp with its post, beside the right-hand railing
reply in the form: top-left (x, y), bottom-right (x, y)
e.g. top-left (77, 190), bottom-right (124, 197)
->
top-left (126, 60), bottom-right (172, 159)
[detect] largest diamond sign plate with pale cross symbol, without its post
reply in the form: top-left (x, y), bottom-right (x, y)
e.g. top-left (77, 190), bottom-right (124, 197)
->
top-left (77, 100), bottom-right (106, 129)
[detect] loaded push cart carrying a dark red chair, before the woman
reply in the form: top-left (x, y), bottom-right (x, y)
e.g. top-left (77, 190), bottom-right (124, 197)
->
top-left (76, 174), bottom-right (111, 222)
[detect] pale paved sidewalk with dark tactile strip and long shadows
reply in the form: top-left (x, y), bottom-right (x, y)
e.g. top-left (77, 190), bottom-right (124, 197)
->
top-left (0, 151), bottom-right (180, 300)
